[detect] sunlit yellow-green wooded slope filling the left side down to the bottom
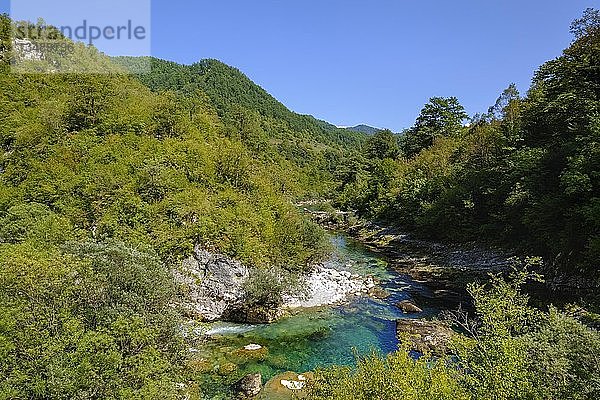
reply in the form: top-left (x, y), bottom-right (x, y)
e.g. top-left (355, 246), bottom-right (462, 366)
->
top-left (0, 13), bottom-right (358, 398)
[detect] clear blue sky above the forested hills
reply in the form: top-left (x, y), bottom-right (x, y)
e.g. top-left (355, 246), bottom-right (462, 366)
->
top-left (0, 0), bottom-right (600, 131)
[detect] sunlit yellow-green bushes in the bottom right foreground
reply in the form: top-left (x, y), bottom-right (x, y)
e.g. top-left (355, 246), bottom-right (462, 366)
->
top-left (307, 272), bottom-right (600, 400)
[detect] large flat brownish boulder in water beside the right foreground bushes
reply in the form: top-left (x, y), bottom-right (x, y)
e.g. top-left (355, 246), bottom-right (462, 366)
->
top-left (396, 319), bottom-right (455, 354)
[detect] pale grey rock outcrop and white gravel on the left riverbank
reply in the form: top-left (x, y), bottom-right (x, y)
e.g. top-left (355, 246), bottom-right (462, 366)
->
top-left (173, 246), bottom-right (377, 323)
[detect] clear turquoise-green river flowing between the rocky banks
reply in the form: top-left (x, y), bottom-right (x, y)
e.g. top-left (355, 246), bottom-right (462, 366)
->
top-left (192, 233), bottom-right (464, 399)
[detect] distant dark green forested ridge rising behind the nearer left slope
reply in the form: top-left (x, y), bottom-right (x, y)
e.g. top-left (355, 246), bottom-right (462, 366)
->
top-left (114, 57), bottom-right (365, 172)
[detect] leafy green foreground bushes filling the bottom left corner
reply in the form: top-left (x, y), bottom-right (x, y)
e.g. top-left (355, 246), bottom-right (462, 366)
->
top-left (0, 240), bottom-right (183, 399)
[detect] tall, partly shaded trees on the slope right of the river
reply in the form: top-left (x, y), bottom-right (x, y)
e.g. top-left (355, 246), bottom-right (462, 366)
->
top-left (338, 10), bottom-right (600, 287)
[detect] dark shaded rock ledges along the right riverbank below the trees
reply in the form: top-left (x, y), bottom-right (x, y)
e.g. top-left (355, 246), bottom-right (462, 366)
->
top-left (303, 207), bottom-right (600, 302)
